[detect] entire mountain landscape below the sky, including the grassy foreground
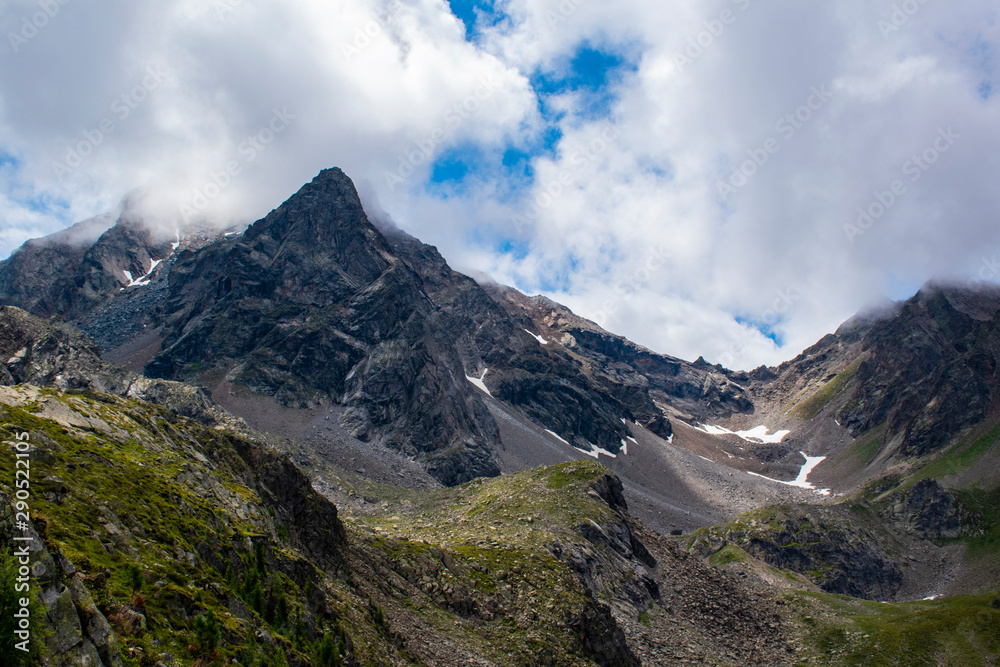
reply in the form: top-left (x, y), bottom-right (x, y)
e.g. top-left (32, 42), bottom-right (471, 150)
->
top-left (0, 169), bottom-right (1000, 665)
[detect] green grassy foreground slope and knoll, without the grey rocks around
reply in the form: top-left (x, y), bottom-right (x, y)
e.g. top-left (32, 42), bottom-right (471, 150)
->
top-left (0, 386), bottom-right (638, 667)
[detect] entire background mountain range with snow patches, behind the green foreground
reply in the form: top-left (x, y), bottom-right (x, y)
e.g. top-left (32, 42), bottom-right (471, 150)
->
top-left (0, 168), bottom-right (1000, 528)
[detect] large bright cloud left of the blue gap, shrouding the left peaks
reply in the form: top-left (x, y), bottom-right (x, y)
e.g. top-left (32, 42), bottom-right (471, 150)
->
top-left (0, 0), bottom-right (532, 234)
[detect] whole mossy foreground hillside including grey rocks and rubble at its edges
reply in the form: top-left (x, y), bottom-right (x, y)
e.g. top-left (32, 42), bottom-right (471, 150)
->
top-left (0, 308), bottom-right (798, 666)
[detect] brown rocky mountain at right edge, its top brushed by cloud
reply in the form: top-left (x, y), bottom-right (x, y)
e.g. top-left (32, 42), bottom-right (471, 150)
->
top-left (716, 282), bottom-right (1000, 490)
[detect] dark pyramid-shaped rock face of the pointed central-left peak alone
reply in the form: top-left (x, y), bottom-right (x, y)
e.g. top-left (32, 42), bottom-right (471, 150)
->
top-left (146, 170), bottom-right (499, 484)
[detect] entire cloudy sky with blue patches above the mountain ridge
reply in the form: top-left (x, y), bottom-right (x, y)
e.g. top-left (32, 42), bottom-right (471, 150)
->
top-left (0, 0), bottom-right (1000, 368)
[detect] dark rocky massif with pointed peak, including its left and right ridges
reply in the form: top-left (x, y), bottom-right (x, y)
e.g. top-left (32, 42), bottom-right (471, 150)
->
top-left (0, 169), bottom-right (750, 484)
